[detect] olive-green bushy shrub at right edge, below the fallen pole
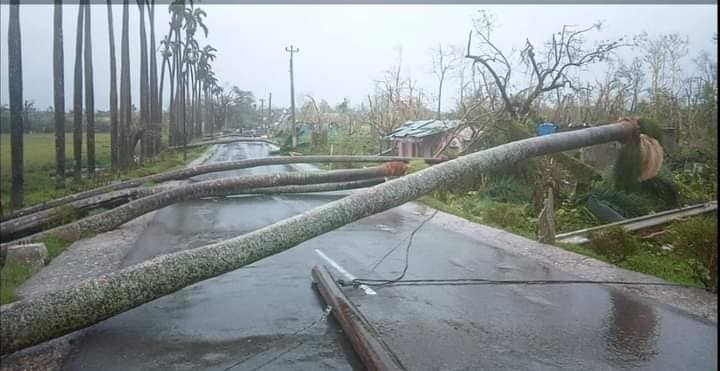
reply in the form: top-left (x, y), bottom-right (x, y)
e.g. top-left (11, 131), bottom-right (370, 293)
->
top-left (667, 215), bottom-right (718, 288)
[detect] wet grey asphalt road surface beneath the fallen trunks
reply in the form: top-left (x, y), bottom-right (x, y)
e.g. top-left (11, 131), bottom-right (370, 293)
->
top-left (65, 143), bottom-right (717, 370)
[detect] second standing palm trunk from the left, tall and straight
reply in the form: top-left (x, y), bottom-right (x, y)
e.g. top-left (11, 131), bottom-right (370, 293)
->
top-left (53, 0), bottom-right (65, 189)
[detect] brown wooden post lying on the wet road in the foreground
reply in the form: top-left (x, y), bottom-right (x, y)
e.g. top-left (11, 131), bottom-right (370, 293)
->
top-left (312, 265), bottom-right (405, 370)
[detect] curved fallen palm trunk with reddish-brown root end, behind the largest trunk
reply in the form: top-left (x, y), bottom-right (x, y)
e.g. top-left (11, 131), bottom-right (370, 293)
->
top-left (5, 162), bottom-right (406, 246)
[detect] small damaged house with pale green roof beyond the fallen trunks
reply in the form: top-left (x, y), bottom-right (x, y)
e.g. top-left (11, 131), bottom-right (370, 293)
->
top-left (385, 120), bottom-right (472, 157)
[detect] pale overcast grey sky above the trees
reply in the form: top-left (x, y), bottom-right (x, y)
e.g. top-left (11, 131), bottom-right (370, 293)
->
top-left (0, 3), bottom-right (717, 110)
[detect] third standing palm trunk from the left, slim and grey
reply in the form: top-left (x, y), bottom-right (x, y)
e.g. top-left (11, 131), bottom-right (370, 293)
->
top-left (73, 4), bottom-right (84, 181)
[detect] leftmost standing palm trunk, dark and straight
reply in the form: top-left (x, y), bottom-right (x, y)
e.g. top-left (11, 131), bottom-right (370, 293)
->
top-left (8, 0), bottom-right (23, 209)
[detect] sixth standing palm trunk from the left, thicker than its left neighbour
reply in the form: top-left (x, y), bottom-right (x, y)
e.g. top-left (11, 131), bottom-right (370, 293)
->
top-left (118, 0), bottom-right (132, 169)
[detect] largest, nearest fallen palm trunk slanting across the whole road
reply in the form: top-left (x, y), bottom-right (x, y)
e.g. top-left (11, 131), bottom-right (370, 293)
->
top-left (0, 122), bottom-right (638, 353)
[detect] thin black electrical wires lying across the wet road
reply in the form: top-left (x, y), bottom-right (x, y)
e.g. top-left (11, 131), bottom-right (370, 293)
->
top-left (350, 210), bottom-right (713, 291)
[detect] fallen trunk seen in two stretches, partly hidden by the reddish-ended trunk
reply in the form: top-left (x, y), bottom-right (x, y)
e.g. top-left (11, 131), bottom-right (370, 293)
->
top-left (0, 178), bottom-right (385, 242)
